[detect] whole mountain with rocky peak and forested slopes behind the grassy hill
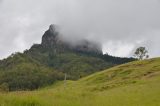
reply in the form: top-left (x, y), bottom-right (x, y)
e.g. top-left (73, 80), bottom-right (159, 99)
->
top-left (0, 25), bottom-right (135, 90)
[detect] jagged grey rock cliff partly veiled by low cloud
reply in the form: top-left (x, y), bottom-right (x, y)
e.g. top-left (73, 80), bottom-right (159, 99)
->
top-left (41, 24), bottom-right (102, 54)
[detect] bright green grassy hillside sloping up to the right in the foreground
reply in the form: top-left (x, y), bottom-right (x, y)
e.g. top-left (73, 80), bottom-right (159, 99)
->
top-left (0, 58), bottom-right (160, 106)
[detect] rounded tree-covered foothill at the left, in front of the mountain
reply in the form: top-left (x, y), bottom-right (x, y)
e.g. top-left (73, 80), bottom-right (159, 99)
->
top-left (0, 53), bottom-right (64, 91)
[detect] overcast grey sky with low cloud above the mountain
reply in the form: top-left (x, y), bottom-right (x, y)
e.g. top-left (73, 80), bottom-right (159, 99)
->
top-left (0, 0), bottom-right (160, 59)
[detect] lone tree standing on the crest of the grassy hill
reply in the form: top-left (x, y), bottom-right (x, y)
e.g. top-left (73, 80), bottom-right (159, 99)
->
top-left (134, 47), bottom-right (149, 60)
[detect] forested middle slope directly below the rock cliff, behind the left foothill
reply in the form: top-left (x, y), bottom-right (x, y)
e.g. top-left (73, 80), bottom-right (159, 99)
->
top-left (25, 47), bottom-right (114, 80)
